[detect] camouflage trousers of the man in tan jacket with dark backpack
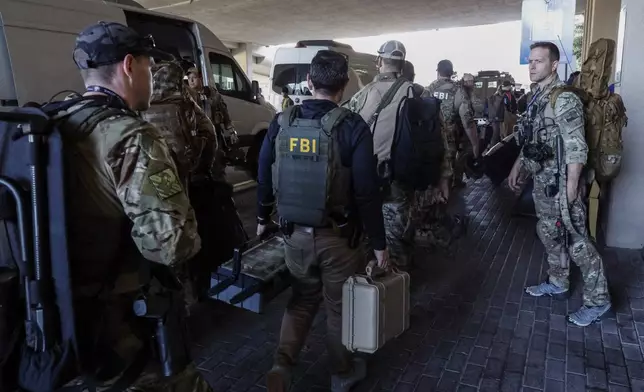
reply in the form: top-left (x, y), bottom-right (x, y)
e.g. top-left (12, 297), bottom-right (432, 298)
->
top-left (382, 190), bottom-right (415, 269)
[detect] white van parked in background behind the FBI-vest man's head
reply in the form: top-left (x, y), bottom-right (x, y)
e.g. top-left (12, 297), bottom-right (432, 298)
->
top-left (268, 40), bottom-right (378, 111)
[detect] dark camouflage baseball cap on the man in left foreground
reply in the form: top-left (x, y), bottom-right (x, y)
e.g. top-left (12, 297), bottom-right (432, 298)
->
top-left (73, 21), bottom-right (174, 69)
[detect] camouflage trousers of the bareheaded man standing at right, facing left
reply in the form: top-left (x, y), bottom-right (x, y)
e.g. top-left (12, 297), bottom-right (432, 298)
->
top-left (533, 176), bottom-right (610, 306)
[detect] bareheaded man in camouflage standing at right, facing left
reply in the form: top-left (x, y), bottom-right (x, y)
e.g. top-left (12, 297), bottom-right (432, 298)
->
top-left (508, 42), bottom-right (611, 327)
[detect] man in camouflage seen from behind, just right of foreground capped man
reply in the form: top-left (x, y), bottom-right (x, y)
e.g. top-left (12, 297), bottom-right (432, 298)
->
top-left (142, 62), bottom-right (247, 300)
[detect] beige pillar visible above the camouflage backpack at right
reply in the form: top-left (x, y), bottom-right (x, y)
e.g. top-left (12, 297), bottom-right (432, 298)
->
top-left (579, 0), bottom-right (622, 79)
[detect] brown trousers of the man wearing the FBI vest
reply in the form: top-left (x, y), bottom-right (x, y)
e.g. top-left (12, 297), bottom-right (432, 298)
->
top-left (275, 227), bottom-right (364, 373)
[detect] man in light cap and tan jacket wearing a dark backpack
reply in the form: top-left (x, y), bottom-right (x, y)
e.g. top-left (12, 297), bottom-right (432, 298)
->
top-left (348, 41), bottom-right (415, 269)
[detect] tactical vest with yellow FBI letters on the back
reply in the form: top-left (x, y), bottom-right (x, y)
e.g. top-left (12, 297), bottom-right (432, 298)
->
top-left (273, 106), bottom-right (351, 227)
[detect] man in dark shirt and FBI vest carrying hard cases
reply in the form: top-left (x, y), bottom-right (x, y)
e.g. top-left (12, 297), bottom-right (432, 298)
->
top-left (257, 50), bottom-right (389, 392)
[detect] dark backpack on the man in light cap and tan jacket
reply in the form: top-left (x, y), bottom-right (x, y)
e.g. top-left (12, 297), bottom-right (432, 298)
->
top-left (382, 83), bottom-right (445, 191)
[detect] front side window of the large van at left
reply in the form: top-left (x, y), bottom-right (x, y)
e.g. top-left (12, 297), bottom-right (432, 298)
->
top-left (208, 52), bottom-right (252, 101)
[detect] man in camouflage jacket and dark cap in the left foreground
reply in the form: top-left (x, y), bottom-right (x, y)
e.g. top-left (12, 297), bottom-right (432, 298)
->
top-left (63, 22), bottom-right (210, 392)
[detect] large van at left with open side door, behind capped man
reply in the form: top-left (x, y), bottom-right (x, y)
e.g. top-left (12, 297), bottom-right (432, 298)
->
top-left (0, 0), bottom-right (275, 173)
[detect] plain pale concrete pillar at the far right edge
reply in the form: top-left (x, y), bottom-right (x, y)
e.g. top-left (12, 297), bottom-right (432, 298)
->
top-left (604, 0), bottom-right (644, 249)
